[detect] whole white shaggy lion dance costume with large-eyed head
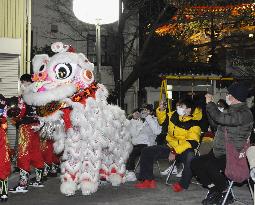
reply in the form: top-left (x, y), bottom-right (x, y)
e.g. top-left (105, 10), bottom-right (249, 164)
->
top-left (23, 42), bottom-right (132, 196)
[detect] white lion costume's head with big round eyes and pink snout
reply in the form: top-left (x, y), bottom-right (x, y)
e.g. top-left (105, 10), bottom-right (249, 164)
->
top-left (23, 42), bottom-right (95, 106)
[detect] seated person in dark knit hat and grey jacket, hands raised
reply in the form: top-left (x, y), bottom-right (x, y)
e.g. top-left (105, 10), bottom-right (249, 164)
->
top-left (191, 83), bottom-right (253, 204)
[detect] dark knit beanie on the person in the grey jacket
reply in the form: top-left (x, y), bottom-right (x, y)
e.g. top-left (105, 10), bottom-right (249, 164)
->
top-left (227, 82), bottom-right (249, 102)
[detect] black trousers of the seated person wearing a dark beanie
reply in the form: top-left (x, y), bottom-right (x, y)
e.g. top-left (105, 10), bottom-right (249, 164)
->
top-left (191, 150), bottom-right (228, 192)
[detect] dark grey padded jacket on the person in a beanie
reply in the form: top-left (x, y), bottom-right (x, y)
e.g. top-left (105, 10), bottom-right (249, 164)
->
top-left (206, 102), bottom-right (253, 157)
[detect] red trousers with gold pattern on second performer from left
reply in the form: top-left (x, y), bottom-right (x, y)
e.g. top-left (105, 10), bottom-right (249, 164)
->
top-left (17, 123), bottom-right (44, 172)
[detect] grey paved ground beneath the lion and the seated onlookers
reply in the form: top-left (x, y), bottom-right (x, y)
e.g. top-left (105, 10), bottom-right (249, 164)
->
top-left (5, 163), bottom-right (253, 205)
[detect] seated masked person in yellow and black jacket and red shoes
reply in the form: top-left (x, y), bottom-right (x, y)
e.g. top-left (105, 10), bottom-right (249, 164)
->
top-left (135, 98), bottom-right (202, 192)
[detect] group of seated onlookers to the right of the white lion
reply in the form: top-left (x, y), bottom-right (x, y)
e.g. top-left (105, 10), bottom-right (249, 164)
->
top-left (126, 82), bottom-right (255, 204)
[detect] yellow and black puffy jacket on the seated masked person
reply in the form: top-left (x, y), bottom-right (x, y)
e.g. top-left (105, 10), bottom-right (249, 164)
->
top-left (156, 108), bottom-right (202, 154)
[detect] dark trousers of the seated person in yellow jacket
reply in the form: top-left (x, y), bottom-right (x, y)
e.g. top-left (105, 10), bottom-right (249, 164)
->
top-left (139, 145), bottom-right (194, 189)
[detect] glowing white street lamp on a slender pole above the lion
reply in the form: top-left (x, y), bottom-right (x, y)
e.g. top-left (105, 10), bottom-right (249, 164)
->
top-left (73, 0), bottom-right (119, 81)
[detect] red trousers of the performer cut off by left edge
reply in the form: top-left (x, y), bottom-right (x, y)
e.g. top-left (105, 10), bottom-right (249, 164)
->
top-left (0, 126), bottom-right (11, 180)
